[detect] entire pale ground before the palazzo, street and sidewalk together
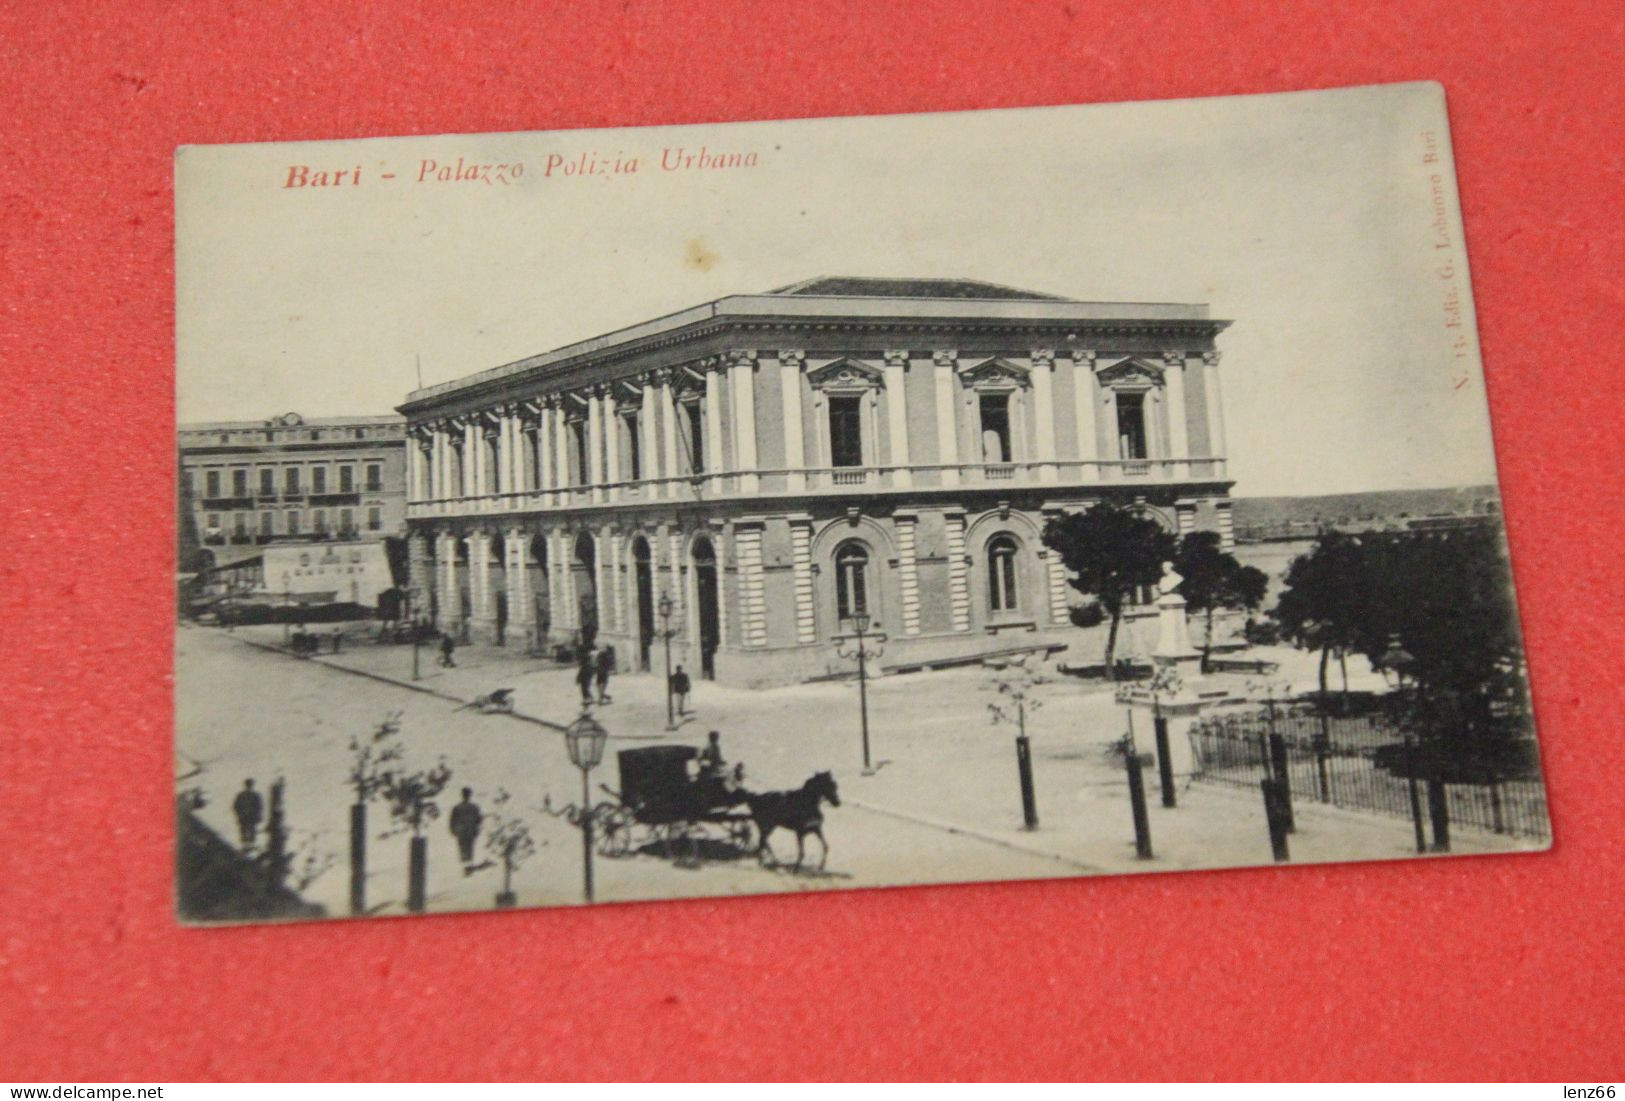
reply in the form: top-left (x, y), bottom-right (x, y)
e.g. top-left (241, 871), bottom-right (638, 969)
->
top-left (177, 627), bottom-right (1519, 916)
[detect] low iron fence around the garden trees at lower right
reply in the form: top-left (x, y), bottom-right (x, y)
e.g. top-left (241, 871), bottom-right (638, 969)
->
top-left (1191, 703), bottom-right (1552, 840)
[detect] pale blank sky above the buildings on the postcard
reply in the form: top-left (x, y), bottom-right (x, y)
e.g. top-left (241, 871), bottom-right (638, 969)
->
top-left (176, 84), bottom-right (1495, 495)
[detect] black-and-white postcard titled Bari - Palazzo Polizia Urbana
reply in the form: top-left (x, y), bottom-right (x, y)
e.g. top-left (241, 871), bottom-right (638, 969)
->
top-left (176, 84), bottom-right (1550, 922)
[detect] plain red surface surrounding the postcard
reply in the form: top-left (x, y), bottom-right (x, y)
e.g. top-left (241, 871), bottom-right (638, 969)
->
top-left (0, 0), bottom-right (1625, 1082)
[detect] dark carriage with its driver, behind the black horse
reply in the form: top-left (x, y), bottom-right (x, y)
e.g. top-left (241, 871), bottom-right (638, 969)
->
top-left (593, 745), bottom-right (752, 859)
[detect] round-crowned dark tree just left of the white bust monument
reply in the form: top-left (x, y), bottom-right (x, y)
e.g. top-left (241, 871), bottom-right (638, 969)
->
top-left (1043, 502), bottom-right (1175, 680)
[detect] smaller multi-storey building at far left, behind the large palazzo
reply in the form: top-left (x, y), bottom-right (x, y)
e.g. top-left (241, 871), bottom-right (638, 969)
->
top-left (177, 412), bottom-right (406, 604)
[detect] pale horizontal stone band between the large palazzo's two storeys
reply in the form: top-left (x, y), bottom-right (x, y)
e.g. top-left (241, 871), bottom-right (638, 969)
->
top-left (406, 456), bottom-right (1225, 520)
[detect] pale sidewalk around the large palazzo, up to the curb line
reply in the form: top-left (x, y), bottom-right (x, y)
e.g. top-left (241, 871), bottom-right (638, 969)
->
top-left (219, 627), bottom-right (1536, 880)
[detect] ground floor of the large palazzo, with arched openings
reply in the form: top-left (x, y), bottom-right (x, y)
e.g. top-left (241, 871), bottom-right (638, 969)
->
top-left (411, 492), bottom-right (1229, 687)
